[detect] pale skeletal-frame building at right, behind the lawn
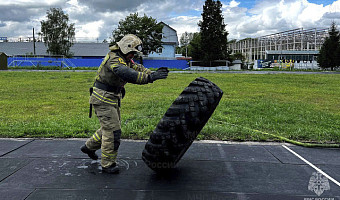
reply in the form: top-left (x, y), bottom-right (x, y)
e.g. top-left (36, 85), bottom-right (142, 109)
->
top-left (229, 28), bottom-right (328, 63)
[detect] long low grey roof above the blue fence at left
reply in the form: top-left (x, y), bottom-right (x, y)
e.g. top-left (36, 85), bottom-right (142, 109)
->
top-left (0, 42), bottom-right (109, 57)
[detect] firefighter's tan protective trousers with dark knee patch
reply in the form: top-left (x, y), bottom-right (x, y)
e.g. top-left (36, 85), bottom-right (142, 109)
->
top-left (86, 103), bottom-right (121, 168)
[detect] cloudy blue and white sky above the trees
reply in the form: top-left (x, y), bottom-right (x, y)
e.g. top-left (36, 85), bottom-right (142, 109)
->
top-left (0, 0), bottom-right (340, 42)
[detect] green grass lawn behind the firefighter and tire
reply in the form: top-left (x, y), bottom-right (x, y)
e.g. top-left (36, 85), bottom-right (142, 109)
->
top-left (0, 71), bottom-right (340, 143)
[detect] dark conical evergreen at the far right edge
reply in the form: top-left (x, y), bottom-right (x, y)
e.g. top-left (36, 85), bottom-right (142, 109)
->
top-left (318, 22), bottom-right (340, 71)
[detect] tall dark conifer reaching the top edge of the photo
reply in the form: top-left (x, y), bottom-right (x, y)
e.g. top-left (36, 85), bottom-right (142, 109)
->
top-left (198, 0), bottom-right (229, 62)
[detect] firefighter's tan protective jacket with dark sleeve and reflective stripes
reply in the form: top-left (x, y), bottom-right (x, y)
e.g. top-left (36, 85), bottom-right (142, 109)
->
top-left (90, 45), bottom-right (151, 105)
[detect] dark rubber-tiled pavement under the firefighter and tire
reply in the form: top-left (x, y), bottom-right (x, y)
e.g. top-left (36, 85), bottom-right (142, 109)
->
top-left (0, 139), bottom-right (340, 200)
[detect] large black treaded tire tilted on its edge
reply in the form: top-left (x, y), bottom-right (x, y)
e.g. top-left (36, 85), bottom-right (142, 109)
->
top-left (142, 77), bottom-right (223, 172)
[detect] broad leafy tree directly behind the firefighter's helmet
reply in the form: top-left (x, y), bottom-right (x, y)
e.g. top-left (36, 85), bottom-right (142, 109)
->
top-left (111, 13), bottom-right (163, 55)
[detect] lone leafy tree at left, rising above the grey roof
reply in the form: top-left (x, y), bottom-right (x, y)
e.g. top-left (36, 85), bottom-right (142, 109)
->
top-left (39, 8), bottom-right (75, 57)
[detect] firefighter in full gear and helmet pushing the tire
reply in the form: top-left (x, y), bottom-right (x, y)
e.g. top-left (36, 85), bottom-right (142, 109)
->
top-left (81, 34), bottom-right (169, 173)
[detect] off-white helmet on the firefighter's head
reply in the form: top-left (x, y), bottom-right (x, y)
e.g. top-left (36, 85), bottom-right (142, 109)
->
top-left (117, 34), bottom-right (142, 54)
